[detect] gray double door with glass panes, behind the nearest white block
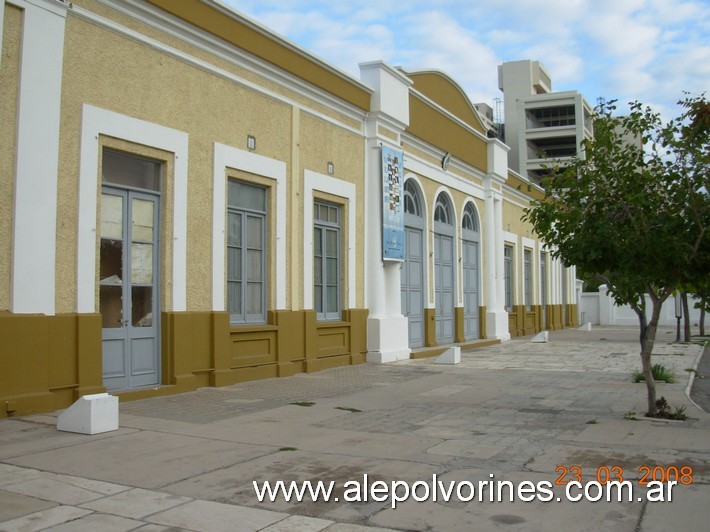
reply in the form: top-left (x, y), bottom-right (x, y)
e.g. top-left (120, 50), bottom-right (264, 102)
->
top-left (99, 186), bottom-right (160, 390)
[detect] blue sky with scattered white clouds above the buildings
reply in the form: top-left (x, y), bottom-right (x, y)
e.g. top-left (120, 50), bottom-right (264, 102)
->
top-left (222, 0), bottom-right (710, 118)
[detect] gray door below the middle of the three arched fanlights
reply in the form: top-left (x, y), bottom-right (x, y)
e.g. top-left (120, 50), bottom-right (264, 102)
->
top-left (434, 233), bottom-right (454, 344)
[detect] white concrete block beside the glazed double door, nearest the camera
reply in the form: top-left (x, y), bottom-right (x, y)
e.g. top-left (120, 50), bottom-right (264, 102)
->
top-left (57, 393), bottom-right (118, 434)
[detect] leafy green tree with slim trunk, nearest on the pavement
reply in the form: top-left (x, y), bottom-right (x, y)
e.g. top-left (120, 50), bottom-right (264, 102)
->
top-left (524, 94), bottom-right (710, 417)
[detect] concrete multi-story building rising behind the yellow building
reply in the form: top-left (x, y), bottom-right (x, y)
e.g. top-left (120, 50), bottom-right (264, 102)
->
top-left (498, 60), bottom-right (592, 183)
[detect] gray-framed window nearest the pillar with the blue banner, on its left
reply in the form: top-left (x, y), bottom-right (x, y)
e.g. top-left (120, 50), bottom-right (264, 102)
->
top-left (313, 201), bottom-right (341, 320)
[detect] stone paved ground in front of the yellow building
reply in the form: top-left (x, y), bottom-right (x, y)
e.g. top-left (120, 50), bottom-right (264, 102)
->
top-left (0, 328), bottom-right (710, 532)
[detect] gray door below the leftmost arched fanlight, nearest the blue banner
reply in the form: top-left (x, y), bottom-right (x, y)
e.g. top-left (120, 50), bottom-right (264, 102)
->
top-left (401, 227), bottom-right (424, 347)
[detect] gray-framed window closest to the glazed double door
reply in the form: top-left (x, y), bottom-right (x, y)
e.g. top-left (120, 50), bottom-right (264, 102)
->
top-left (227, 180), bottom-right (267, 323)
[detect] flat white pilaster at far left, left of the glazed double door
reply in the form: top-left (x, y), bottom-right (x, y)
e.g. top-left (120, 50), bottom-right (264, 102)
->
top-left (10, 1), bottom-right (66, 315)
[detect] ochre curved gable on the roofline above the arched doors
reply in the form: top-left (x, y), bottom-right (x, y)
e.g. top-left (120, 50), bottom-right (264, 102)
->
top-left (405, 70), bottom-right (486, 135)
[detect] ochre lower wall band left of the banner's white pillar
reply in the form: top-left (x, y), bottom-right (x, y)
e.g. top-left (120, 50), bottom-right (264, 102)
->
top-left (0, 309), bottom-right (367, 418)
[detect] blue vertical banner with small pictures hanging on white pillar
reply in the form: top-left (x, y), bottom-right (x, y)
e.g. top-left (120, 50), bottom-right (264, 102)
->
top-left (382, 146), bottom-right (404, 261)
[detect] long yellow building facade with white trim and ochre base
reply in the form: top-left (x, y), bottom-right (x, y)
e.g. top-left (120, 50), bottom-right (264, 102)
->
top-left (0, 0), bottom-right (576, 417)
